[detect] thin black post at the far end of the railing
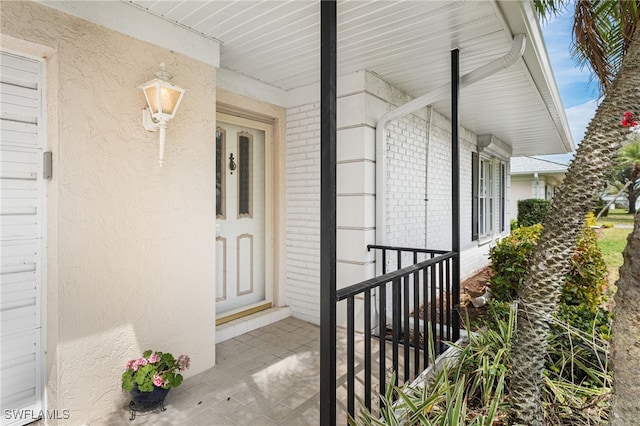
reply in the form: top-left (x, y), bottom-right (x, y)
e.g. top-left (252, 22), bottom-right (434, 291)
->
top-left (451, 49), bottom-right (460, 341)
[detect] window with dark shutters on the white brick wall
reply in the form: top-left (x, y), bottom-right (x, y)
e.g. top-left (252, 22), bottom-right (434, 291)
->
top-left (471, 152), bottom-right (507, 240)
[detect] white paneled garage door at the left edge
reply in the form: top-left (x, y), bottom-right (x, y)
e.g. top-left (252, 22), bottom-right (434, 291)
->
top-left (0, 52), bottom-right (45, 426)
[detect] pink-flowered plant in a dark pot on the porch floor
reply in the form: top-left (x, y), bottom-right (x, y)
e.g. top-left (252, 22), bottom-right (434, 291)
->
top-left (122, 350), bottom-right (191, 410)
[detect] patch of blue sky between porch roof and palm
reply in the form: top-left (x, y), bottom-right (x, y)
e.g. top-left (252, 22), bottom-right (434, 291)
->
top-left (541, 8), bottom-right (598, 163)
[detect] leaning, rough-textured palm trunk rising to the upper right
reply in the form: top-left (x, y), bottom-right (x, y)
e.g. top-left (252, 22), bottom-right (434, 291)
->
top-left (510, 32), bottom-right (640, 425)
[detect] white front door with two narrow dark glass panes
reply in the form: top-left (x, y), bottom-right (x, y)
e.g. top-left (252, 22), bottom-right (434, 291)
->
top-left (216, 114), bottom-right (273, 320)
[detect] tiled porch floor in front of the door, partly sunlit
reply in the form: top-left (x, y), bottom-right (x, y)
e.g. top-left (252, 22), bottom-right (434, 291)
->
top-left (97, 318), bottom-right (347, 426)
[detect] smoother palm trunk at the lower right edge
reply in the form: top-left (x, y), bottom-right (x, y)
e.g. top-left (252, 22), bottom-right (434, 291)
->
top-left (609, 215), bottom-right (640, 426)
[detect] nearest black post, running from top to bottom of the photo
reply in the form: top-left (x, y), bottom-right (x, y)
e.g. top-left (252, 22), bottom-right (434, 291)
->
top-left (320, 0), bottom-right (337, 426)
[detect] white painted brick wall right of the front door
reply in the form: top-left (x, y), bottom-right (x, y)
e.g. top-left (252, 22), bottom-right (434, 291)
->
top-left (286, 72), bottom-right (510, 323)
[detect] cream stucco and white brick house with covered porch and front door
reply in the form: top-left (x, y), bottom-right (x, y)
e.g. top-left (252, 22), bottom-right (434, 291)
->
top-left (0, 0), bottom-right (574, 425)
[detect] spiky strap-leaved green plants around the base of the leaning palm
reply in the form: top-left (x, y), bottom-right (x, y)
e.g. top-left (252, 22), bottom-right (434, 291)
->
top-left (349, 299), bottom-right (612, 426)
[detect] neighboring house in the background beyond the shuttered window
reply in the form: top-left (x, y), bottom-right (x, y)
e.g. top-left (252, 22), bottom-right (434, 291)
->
top-left (511, 157), bottom-right (569, 220)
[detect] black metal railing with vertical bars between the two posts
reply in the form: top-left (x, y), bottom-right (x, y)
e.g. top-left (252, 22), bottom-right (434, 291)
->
top-left (336, 245), bottom-right (460, 417)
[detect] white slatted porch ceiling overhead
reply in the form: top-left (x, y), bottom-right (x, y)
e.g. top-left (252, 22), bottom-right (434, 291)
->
top-left (123, 0), bottom-right (573, 155)
